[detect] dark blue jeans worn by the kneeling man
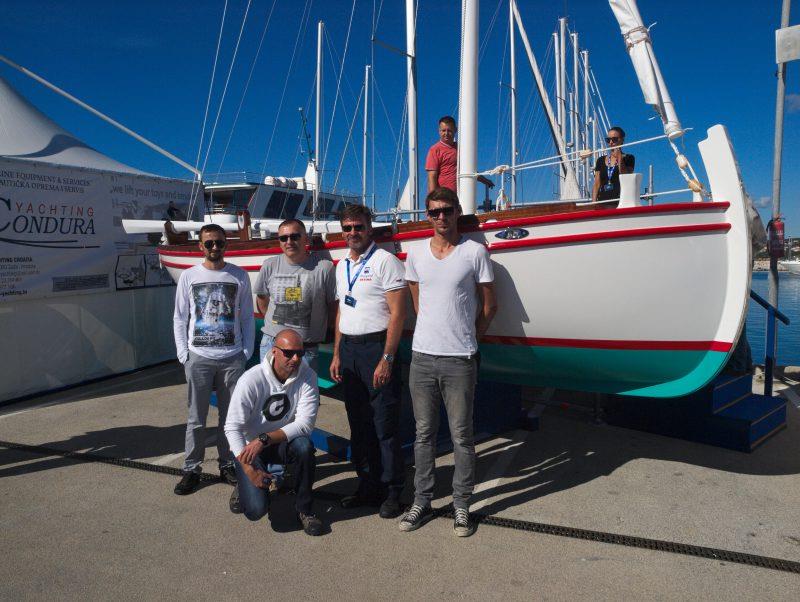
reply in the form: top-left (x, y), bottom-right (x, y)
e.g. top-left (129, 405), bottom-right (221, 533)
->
top-left (236, 437), bottom-right (316, 520)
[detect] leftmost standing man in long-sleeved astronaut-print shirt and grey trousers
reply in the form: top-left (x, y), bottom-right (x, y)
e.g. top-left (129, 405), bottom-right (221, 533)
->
top-left (172, 224), bottom-right (255, 495)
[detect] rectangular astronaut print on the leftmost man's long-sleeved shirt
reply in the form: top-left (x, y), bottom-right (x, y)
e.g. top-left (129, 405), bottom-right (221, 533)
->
top-left (192, 282), bottom-right (239, 347)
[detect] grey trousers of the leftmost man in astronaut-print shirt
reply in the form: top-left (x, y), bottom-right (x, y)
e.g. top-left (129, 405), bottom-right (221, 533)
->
top-left (183, 351), bottom-right (246, 473)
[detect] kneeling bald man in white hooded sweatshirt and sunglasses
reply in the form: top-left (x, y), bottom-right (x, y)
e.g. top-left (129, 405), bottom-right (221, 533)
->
top-left (225, 328), bottom-right (322, 535)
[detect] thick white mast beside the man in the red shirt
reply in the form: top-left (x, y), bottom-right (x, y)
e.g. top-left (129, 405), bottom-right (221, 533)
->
top-left (458, 0), bottom-right (479, 215)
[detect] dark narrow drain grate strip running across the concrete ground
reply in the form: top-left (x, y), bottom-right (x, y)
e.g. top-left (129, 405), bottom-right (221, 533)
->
top-left (0, 441), bottom-right (800, 574)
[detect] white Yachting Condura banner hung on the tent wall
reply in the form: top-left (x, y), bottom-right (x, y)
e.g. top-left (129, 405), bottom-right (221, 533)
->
top-left (0, 160), bottom-right (191, 302)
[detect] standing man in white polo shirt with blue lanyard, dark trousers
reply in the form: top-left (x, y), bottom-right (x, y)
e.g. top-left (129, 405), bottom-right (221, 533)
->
top-left (331, 205), bottom-right (406, 518)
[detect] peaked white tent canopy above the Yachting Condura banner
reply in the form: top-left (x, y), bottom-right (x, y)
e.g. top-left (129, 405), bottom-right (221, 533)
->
top-left (0, 77), bottom-right (144, 174)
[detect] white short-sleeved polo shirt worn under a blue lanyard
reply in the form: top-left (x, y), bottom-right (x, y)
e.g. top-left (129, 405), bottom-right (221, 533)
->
top-left (336, 243), bottom-right (407, 335)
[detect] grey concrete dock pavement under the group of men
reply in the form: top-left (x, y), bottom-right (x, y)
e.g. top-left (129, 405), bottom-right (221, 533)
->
top-left (0, 364), bottom-right (800, 600)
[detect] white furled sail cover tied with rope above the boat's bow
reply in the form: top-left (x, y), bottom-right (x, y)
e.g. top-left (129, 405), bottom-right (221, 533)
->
top-left (609, 0), bottom-right (683, 138)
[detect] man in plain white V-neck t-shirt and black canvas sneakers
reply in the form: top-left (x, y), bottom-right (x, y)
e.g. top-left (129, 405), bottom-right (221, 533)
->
top-left (400, 188), bottom-right (497, 537)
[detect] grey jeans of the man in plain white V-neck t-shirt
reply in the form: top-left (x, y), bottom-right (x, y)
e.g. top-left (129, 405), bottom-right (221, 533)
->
top-left (409, 351), bottom-right (477, 510)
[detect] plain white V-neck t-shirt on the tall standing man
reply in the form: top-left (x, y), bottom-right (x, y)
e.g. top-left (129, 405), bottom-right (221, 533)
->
top-left (406, 237), bottom-right (494, 357)
